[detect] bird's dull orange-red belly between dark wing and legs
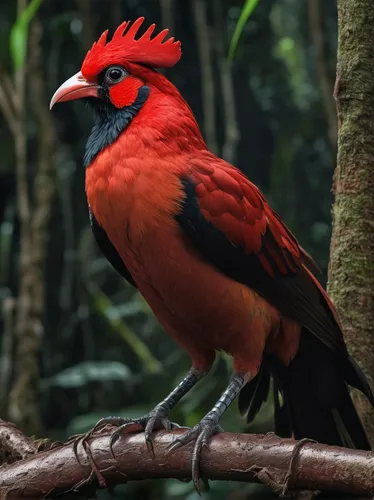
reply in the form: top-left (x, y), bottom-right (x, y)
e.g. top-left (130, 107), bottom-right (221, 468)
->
top-left (112, 217), bottom-right (280, 373)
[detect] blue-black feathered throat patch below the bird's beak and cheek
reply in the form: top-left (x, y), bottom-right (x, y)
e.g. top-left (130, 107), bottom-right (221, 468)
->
top-left (83, 85), bottom-right (150, 167)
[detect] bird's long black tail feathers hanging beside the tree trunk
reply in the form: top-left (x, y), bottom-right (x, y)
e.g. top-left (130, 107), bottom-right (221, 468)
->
top-left (239, 332), bottom-right (374, 450)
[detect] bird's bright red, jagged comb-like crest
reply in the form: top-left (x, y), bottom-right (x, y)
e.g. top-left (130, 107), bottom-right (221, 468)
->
top-left (81, 17), bottom-right (181, 79)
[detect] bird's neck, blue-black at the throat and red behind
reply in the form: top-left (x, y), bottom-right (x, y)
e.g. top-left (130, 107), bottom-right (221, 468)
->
top-left (84, 85), bottom-right (206, 167)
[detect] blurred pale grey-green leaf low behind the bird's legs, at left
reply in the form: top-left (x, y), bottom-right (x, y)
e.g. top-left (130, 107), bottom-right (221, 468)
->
top-left (41, 361), bottom-right (131, 389)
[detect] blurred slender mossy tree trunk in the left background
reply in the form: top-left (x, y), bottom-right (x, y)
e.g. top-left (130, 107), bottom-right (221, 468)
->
top-left (8, 19), bottom-right (56, 434)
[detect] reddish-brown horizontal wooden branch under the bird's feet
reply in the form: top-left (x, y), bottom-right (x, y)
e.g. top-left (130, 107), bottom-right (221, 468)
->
top-left (0, 426), bottom-right (374, 499)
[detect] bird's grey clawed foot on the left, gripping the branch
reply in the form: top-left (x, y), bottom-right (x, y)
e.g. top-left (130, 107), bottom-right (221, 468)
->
top-left (95, 404), bottom-right (180, 457)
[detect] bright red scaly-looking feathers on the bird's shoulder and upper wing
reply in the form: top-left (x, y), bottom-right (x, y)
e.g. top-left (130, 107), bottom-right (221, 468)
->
top-left (182, 152), bottom-right (302, 275)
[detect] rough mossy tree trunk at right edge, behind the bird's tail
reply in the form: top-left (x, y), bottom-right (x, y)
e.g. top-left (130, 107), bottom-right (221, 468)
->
top-left (328, 0), bottom-right (374, 445)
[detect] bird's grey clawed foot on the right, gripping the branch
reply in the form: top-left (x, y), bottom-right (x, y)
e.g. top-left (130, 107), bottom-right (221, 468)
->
top-left (169, 412), bottom-right (223, 494)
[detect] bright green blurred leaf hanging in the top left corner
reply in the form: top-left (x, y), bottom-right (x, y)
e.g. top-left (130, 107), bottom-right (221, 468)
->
top-left (9, 0), bottom-right (43, 72)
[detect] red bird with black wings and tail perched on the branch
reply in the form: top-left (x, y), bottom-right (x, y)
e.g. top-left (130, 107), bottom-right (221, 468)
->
top-left (51, 18), bottom-right (374, 484)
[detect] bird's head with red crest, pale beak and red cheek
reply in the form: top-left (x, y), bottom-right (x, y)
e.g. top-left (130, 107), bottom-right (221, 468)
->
top-left (50, 17), bottom-right (181, 109)
